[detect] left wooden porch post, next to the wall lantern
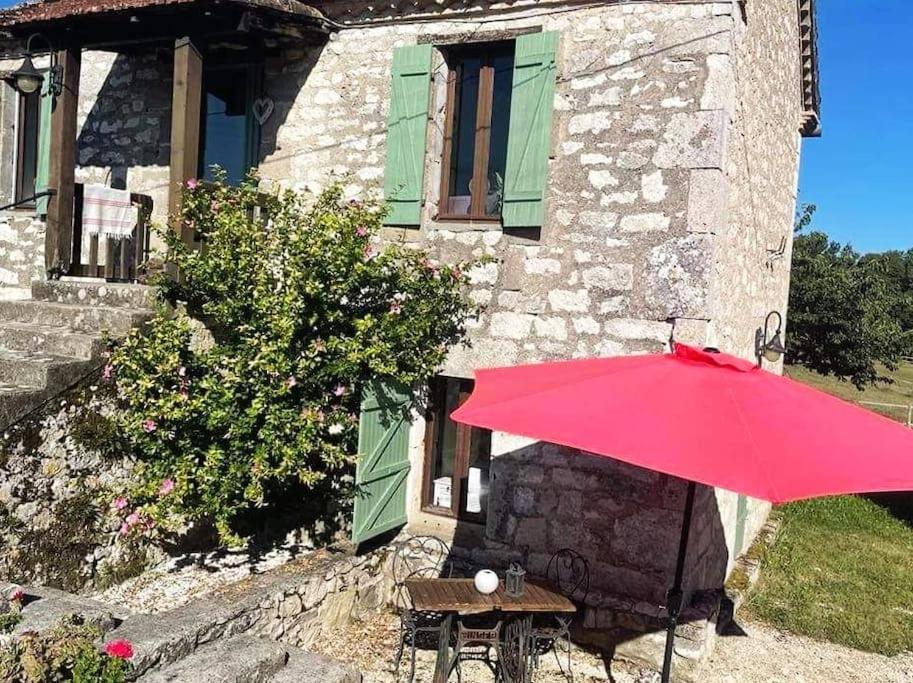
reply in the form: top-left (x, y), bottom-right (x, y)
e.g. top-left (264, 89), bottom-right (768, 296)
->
top-left (44, 47), bottom-right (81, 277)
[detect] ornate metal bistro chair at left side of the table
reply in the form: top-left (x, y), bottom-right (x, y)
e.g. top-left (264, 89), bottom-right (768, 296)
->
top-left (393, 536), bottom-right (453, 683)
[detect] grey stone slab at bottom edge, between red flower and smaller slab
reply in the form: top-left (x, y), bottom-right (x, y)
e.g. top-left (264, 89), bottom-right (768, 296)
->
top-left (138, 635), bottom-right (288, 683)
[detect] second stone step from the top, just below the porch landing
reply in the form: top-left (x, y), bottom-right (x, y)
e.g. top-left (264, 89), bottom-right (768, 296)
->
top-left (0, 300), bottom-right (151, 337)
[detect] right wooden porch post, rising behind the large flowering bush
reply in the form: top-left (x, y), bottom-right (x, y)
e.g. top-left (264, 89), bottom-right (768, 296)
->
top-left (168, 38), bottom-right (203, 254)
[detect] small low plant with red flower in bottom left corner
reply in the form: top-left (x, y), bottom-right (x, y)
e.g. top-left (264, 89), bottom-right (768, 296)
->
top-left (0, 617), bottom-right (133, 683)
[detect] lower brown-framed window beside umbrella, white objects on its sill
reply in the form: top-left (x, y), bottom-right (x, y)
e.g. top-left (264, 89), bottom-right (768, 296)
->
top-left (422, 377), bottom-right (491, 523)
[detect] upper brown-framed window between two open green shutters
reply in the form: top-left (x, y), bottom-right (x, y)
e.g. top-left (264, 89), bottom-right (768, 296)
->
top-left (438, 42), bottom-right (514, 220)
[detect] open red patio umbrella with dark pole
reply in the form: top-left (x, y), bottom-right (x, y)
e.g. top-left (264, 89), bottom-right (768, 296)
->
top-left (451, 344), bottom-right (913, 681)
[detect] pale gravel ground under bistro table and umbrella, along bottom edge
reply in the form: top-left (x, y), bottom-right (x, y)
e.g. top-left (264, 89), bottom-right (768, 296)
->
top-left (319, 613), bottom-right (913, 683)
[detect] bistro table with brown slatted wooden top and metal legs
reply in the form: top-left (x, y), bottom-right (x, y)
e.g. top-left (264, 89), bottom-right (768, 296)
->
top-left (406, 578), bottom-right (577, 683)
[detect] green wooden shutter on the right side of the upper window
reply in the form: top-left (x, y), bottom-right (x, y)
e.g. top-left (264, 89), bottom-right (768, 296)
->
top-left (501, 31), bottom-right (558, 228)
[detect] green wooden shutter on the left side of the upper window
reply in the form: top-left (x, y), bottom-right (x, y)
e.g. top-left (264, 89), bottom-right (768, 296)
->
top-left (384, 45), bottom-right (431, 225)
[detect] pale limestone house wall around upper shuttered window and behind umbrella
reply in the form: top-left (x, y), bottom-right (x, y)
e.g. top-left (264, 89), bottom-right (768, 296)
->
top-left (261, 2), bottom-right (799, 620)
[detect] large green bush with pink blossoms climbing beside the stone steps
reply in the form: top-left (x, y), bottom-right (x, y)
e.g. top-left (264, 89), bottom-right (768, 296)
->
top-left (105, 177), bottom-right (474, 544)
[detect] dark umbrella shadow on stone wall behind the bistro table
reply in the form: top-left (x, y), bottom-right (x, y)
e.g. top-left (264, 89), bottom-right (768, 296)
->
top-left (454, 443), bottom-right (729, 662)
